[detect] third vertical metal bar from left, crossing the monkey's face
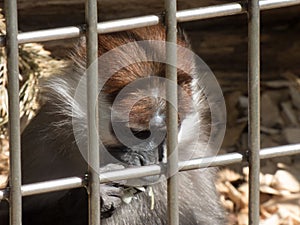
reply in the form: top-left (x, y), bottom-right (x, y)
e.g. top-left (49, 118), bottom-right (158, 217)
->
top-left (165, 0), bottom-right (179, 225)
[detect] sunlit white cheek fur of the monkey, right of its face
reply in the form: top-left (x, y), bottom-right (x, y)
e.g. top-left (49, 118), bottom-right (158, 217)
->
top-left (178, 112), bottom-right (207, 161)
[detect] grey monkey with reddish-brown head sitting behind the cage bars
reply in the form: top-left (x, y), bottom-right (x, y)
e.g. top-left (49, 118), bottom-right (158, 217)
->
top-left (0, 25), bottom-right (226, 225)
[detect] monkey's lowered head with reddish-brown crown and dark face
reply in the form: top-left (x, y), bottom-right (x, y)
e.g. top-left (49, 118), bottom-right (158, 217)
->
top-left (46, 26), bottom-right (199, 185)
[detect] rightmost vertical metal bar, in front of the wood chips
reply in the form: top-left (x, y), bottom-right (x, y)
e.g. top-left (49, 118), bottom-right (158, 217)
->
top-left (248, 0), bottom-right (260, 225)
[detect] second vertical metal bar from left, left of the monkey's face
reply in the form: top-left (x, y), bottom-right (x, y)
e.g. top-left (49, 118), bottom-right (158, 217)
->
top-left (86, 0), bottom-right (100, 225)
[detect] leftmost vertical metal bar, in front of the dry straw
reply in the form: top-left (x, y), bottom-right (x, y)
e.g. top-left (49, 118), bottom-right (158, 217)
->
top-left (5, 0), bottom-right (22, 225)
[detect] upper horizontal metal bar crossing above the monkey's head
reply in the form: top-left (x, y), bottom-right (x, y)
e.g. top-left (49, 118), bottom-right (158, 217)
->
top-left (0, 0), bottom-right (300, 47)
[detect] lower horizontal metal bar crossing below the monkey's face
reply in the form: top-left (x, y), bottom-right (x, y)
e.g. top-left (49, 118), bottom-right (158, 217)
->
top-left (0, 144), bottom-right (300, 200)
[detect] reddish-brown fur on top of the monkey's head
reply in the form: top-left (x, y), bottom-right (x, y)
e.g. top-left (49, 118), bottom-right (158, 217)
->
top-left (46, 24), bottom-right (209, 144)
